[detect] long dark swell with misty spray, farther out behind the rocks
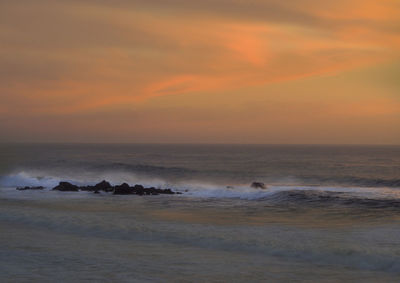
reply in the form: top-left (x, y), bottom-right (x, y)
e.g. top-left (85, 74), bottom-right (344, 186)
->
top-left (4, 159), bottom-right (400, 188)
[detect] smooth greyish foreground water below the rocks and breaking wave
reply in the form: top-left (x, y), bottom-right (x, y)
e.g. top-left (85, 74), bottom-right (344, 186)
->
top-left (0, 192), bottom-right (400, 282)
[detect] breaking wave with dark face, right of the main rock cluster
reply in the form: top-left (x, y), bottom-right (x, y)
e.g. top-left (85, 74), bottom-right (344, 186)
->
top-left (180, 185), bottom-right (400, 208)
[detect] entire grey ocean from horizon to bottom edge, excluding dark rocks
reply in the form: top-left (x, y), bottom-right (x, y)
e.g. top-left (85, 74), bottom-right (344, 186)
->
top-left (0, 144), bottom-right (400, 282)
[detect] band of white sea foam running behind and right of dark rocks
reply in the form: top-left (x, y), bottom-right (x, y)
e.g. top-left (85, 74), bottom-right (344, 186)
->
top-left (0, 171), bottom-right (400, 200)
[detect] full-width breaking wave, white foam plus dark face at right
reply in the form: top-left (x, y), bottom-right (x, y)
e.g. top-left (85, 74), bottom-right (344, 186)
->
top-left (0, 171), bottom-right (400, 208)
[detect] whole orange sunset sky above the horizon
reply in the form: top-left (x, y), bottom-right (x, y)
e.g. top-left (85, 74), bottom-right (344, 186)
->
top-left (0, 0), bottom-right (400, 144)
